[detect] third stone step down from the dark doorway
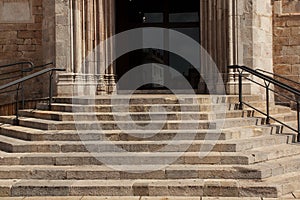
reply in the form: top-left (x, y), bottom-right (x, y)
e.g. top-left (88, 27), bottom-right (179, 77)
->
top-left (19, 110), bottom-right (253, 121)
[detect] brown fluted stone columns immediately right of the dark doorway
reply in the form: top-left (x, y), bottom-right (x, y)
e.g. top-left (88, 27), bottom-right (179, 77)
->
top-left (199, 0), bottom-right (230, 93)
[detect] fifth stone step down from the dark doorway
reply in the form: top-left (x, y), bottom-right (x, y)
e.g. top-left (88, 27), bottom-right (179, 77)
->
top-left (0, 124), bottom-right (279, 141)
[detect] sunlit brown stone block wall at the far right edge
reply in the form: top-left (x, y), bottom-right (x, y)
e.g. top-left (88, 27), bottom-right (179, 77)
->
top-left (273, 0), bottom-right (300, 104)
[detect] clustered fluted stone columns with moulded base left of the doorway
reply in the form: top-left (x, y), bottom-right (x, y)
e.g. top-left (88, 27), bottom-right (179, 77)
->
top-left (56, 0), bottom-right (115, 95)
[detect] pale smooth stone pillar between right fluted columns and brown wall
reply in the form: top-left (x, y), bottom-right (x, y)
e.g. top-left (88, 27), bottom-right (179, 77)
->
top-left (227, 0), bottom-right (273, 97)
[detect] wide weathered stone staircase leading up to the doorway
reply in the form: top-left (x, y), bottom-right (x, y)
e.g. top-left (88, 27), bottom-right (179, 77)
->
top-left (0, 95), bottom-right (300, 198)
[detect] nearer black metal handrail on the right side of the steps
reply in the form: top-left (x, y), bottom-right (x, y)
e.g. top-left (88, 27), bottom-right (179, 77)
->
top-left (228, 65), bottom-right (300, 142)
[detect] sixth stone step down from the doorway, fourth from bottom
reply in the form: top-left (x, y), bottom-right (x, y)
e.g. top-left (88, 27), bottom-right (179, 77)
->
top-left (0, 135), bottom-right (288, 153)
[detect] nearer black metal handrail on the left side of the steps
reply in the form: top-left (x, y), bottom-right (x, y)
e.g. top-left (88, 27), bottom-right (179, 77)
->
top-left (0, 66), bottom-right (66, 125)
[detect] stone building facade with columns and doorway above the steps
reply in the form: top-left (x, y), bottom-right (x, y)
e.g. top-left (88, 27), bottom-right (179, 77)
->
top-left (0, 0), bottom-right (300, 103)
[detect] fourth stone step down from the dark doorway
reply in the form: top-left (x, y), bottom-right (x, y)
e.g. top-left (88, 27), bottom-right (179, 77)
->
top-left (0, 116), bottom-right (262, 131)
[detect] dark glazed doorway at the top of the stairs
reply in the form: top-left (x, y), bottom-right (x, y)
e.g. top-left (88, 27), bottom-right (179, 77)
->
top-left (116, 0), bottom-right (200, 90)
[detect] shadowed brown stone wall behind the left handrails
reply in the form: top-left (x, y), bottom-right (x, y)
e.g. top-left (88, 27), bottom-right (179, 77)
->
top-left (0, 0), bottom-right (49, 105)
